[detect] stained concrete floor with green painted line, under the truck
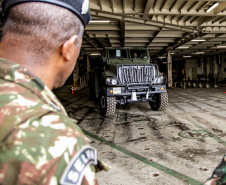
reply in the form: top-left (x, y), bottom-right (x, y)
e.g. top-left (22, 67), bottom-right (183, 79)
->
top-left (55, 86), bottom-right (226, 185)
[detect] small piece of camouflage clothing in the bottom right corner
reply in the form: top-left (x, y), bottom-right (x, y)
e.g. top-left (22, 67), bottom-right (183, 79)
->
top-left (204, 155), bottom-right (226, 185)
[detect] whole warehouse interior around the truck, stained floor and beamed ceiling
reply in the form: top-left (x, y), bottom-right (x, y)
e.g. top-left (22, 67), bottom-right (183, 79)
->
top-left (55, 0), bottom-right (226, 185)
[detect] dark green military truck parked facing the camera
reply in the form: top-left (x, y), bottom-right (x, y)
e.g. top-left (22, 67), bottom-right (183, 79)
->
top-left (89, 48), bottom-right (168, 116)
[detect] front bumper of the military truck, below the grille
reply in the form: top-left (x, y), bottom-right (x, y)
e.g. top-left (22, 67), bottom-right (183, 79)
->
top-left (107, 85), bottom-right (166, 105)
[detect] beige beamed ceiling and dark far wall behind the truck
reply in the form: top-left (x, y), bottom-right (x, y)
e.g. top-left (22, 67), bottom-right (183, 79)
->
top-left (71, 0), bottom-right (226, 87)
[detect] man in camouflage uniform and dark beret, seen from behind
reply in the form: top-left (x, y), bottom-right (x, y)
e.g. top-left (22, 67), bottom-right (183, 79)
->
top-left (0, 0), bottom-right (100, 185)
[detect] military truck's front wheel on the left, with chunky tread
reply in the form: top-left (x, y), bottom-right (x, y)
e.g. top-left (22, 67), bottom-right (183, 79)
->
top-left (100, 88), bottom-right (116, 116)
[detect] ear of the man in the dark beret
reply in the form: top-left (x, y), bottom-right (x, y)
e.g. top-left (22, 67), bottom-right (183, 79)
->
top-left (61, 35), bottom-right (78, 61)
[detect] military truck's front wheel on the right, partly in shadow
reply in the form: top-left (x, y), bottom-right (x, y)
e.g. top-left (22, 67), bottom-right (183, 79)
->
top-left (149, 92), bottom-right (168, 110)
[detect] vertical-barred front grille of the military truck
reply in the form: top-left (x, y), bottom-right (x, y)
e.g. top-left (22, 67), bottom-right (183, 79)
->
top-left (117, 64), bottom-right (159, 85)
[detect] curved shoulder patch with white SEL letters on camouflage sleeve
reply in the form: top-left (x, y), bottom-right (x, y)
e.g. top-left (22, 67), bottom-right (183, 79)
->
top-left (60, 146), bottom-right (97, 185)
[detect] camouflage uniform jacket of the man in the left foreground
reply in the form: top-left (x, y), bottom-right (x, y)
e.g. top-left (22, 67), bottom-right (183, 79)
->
top-left (0, 58), bottom-right (96, 185)
